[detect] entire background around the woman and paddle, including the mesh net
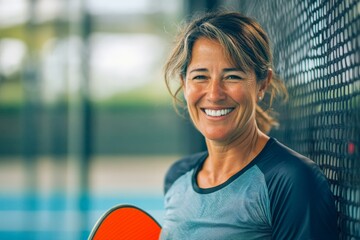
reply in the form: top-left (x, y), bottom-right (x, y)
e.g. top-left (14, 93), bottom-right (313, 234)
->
top-left (0, 0), bottom-right (360, 240)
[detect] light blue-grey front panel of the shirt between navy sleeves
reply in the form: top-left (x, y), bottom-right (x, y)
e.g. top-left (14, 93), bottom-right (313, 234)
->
top-left (161, 166), bottom-right (271, 240)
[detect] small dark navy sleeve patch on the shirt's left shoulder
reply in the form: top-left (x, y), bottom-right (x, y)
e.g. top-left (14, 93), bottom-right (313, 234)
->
top-left (164, 151), bottom-right (208, 193)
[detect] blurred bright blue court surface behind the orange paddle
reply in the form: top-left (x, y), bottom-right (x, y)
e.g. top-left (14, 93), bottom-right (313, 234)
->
top-left (0, 193), bottom-right (163, 240)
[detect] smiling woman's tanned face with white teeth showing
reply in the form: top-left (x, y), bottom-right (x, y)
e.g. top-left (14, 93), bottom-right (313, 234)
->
top-left (183, 38), bottom-right (259, 143)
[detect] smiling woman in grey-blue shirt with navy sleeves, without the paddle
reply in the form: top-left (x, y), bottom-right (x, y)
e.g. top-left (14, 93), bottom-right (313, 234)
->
top-left (161, 12), bottom-right (338, 240)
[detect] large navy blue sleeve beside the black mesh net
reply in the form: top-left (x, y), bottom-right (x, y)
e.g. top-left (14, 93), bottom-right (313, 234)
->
top-left (259, 142), bottom-right (339, 240)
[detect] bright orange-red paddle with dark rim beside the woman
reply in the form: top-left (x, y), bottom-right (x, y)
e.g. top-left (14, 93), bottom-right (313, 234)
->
top-left (88, 205), bottom-right (161, 240)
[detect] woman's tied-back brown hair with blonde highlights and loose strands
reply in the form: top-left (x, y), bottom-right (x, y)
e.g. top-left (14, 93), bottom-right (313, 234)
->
top-left (164, 12), bottom-right (287, 132)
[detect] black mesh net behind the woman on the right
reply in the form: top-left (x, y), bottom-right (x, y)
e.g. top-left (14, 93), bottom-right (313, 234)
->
top-left (235, 0), bottom-right (360, 239)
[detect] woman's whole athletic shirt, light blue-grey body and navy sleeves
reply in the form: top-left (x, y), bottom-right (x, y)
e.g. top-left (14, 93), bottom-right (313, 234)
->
top-left (160, 138), bottom-right (338, 240)
